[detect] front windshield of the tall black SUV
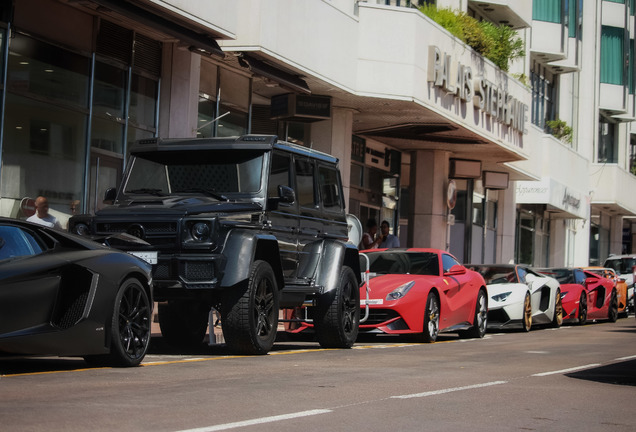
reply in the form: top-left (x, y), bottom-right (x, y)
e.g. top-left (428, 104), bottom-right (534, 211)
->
top-left (123, 151), bottom-right (264, 199)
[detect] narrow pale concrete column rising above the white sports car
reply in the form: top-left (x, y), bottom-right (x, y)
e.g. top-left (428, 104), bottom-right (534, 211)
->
top-left (496, 182), bottom-right (517, 263)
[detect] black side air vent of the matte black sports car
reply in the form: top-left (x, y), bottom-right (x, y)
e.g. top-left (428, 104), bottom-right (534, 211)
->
top-left (51, 265), bottom-right (93, 330)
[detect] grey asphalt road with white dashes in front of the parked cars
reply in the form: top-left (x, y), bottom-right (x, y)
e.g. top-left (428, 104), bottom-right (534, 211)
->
top-left (0, 315), bottom-right (636, 432)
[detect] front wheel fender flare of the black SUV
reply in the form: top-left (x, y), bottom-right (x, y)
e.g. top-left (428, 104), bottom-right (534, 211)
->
top-left (220, 230), bottom-right (284, 289)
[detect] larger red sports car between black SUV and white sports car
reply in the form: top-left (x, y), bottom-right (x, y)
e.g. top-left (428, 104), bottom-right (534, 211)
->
top-left (360, 248), bottom-right (488, 342)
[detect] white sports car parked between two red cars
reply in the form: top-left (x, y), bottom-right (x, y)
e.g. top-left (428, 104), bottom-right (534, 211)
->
top-left (466, 264), bottom-right (563, 331)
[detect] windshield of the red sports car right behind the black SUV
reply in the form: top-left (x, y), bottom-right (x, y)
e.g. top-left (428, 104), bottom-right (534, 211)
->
top-left (361, 251), bottom-right (439, 276)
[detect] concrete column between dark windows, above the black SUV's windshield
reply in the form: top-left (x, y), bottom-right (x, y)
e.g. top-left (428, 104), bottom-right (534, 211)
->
top-left (159, 44), bottom-right (201, 138)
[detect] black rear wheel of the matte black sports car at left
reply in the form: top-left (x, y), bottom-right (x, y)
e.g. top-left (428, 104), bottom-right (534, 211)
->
top-left (85, 278), bottom-right (152, 367)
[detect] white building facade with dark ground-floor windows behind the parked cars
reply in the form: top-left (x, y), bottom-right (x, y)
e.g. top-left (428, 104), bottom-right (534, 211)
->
top-left (0, 0), bottom-right (636, 266)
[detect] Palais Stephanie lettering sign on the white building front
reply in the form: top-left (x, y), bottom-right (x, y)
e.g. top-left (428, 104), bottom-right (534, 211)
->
top-left (428, 45), bottom-right (528, 134)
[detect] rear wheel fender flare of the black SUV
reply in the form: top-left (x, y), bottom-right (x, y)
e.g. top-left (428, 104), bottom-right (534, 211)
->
top-left (316, 240), bottom-right (362, 293)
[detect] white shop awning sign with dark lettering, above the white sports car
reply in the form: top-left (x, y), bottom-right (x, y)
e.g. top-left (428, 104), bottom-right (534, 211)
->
top-left (516, 177), bottom-right (588, 219)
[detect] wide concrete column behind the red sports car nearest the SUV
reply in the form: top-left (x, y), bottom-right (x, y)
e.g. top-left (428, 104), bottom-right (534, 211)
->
top-left (408, 150), bottom-right (450, 250)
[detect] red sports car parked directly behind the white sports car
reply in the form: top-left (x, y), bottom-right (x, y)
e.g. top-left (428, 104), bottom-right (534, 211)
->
top-left (539, 268), bottom-right (617, 324)
